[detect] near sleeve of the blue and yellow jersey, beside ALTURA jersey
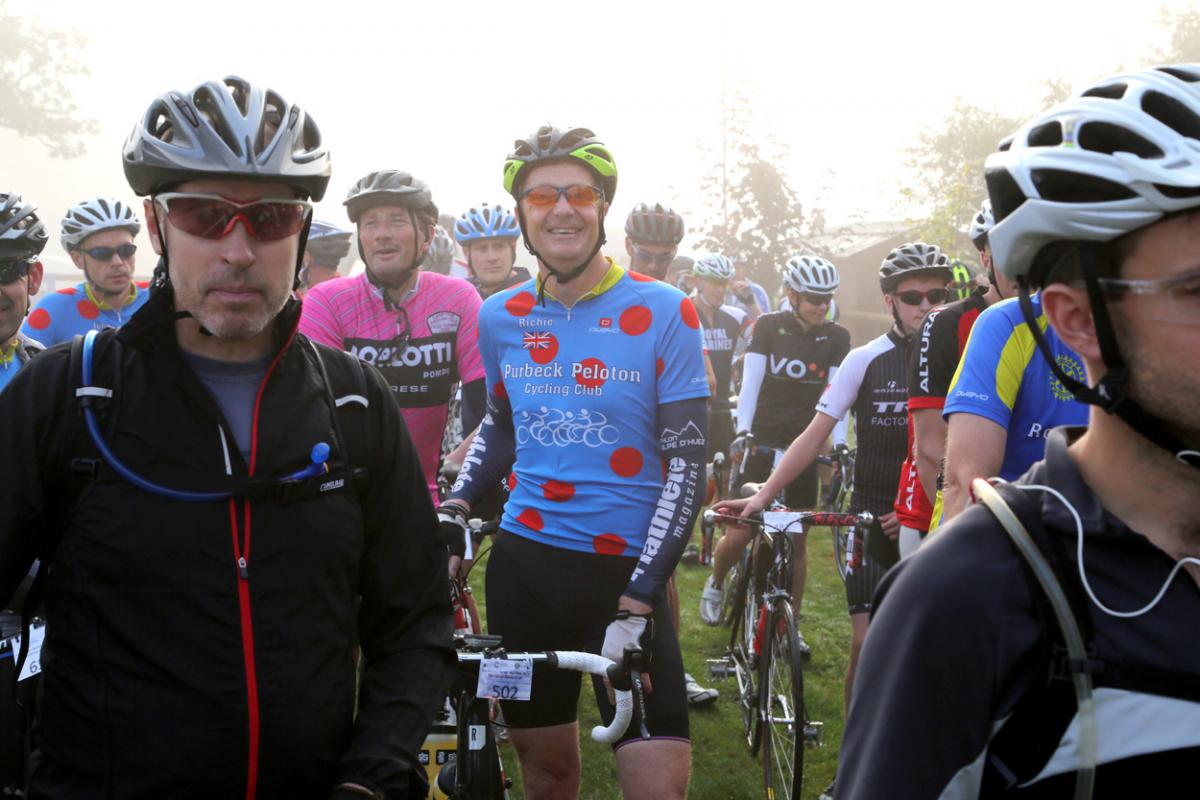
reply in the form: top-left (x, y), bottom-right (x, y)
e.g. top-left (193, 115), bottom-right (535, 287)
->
top-left (942, 303), bottom-right (1025, 428)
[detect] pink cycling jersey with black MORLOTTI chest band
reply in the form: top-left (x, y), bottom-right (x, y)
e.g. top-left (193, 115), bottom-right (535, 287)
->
top-left (300, 272), bottom-right (484, 499)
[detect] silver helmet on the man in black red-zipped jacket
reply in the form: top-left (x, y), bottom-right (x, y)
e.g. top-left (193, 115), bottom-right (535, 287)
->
top-left (122, 76), bottom-right (330, 200)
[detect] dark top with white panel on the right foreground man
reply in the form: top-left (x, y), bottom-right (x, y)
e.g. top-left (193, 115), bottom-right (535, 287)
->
top-left (838, 428), bottom-right (1200, 800)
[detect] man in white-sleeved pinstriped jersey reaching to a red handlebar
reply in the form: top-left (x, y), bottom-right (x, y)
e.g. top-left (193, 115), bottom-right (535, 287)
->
top-left (718, 242), bottom-right (950, 795)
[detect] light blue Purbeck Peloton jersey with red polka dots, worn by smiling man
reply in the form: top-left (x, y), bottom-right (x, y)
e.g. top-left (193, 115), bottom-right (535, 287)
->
top-left (479, 264), bottom-right (708, 557)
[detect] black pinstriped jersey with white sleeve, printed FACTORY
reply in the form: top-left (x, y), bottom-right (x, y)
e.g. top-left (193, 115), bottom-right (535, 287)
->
top-left (817, 330), bottom-right (912, 515)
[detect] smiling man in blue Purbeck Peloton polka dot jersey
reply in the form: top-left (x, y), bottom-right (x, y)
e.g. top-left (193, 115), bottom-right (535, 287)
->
top-left (442, 126), bottom-right (708, 798)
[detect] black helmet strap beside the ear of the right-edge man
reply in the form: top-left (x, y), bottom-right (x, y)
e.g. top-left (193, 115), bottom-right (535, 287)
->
top-left (1018, 277), bottom-right (1200, 469)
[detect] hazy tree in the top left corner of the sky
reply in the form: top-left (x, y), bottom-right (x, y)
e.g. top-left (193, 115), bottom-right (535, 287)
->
top-left (0, 0), bottom-right (97, 158)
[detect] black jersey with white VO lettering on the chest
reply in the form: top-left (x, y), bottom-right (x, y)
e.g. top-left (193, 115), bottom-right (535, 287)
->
top-left (738, 311), bottom-right (854, 450)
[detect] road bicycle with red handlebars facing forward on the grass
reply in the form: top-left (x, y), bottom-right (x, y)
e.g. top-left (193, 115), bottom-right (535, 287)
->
top-left (704, 506), bottom-right (882, 800)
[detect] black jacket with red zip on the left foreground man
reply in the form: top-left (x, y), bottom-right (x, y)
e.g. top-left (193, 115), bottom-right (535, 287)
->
top-left (0, 289), bottom-right (452, 799)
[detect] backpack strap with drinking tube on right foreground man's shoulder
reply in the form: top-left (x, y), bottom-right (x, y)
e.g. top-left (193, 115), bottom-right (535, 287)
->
top-left (971, 479), bottom-right (1103, 800)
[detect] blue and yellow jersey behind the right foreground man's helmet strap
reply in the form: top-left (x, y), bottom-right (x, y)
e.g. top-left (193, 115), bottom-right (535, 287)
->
top-left (942, 295), bottom-right (1087, 481)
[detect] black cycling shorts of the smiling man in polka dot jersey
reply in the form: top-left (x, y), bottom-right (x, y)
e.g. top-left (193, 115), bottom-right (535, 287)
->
top-left (487, 530), bottom-right (690, 750)
